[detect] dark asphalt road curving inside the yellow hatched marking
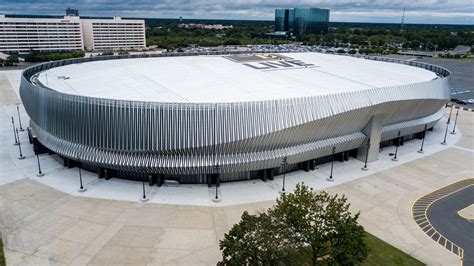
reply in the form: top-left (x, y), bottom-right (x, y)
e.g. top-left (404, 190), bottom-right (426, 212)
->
top-left (427, 186), bottom-right (474, 266)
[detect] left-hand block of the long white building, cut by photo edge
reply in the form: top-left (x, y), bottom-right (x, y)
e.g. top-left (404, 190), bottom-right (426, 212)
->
top-left (0, 14), bottom-right (84, 53)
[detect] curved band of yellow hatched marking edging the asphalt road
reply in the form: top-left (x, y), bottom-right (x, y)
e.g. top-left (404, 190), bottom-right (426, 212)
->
top-left (412, 178), bottom-right (474, 264)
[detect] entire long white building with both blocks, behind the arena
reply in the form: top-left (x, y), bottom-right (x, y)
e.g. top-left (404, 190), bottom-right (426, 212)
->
top-left (0, 13), bottom-right (146, 53)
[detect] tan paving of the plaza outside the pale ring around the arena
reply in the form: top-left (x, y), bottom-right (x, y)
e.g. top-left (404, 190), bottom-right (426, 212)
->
top-left (0, 69), bottom-right (474, 265)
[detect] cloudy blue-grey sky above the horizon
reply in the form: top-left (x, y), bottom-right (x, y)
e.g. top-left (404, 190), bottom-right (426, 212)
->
top-left (0, 0), bottom-right (474, 25)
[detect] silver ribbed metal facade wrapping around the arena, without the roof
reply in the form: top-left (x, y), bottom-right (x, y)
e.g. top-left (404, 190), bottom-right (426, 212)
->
top-left (20, 54), bottom-right (450, 181)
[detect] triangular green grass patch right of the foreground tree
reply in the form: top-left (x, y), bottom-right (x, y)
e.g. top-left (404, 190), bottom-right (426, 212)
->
top-left (362, 233), bottom-right (425, 266)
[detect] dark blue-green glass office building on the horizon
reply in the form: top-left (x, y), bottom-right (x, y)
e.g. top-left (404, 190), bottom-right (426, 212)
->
top-left (275, 8), bottom-right (329, 38)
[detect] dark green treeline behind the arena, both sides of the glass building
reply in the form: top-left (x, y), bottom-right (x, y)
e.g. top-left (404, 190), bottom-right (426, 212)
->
top-left (146, 19), bottom-right (474, 52)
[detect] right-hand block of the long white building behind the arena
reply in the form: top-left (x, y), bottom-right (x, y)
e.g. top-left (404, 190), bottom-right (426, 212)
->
top-left (81, 17), bottom-right (146, 51)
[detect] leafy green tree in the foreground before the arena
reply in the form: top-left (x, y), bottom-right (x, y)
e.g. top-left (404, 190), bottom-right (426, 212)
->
top-left (219, 184), bottom-right (368, 265)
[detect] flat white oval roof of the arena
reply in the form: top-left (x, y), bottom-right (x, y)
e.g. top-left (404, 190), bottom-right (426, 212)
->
top-left (39, 53), bottom-right (436, 103)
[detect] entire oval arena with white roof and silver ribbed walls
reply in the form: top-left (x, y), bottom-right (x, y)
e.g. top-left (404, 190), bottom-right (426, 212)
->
top-left (20, 53), bottom-right (450, 185)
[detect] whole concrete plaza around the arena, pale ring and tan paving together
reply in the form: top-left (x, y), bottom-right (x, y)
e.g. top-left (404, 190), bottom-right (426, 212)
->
top-left (0, 69), bottom-right (474, 265)
